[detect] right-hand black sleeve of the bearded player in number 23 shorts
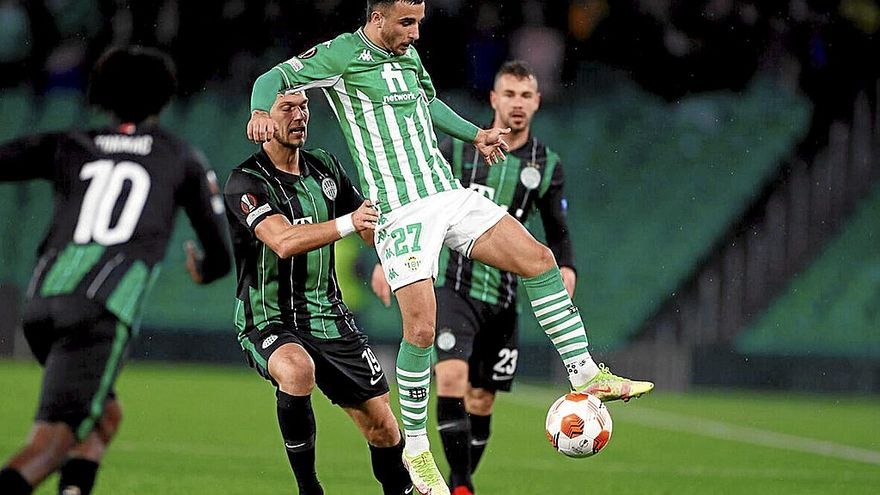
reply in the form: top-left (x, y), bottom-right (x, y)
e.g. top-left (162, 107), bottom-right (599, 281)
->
top-left (536, 162), bottom-right (575, 269)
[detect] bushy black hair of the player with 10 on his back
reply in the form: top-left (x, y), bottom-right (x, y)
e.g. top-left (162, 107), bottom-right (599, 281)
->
top-left (88, 46), bottom-right (177, 123)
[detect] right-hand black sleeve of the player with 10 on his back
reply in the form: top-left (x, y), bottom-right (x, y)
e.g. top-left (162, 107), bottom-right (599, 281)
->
top-left (178, 150), bottom-right (232, 284)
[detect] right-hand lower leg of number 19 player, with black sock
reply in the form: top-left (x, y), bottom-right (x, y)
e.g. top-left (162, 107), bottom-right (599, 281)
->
top-left (344, 393), bottom-right (413, 495)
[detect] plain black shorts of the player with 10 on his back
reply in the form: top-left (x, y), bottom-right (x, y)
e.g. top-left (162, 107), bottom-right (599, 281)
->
top-left (23, 295), bottom-right (131, 439)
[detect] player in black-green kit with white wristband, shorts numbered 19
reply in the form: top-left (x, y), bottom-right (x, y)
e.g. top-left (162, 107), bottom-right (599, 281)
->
top-left (224, 92), bottom-right (413, 495)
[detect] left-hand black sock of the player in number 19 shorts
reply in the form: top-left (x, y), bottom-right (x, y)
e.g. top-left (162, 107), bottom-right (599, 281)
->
top-left (275, 390), bottom-right (324, 495)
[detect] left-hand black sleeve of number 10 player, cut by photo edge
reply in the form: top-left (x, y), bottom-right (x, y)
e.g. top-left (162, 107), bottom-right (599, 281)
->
top-left (0, 134), bottom-right (58, 182)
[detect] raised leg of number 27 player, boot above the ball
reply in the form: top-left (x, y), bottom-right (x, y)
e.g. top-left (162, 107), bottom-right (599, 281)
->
top-left (471, 215), bottom-right (654, 401)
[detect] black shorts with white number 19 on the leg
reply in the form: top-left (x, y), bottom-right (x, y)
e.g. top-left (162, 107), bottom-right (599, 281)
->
top-left (239, 325), bottom-right (388, 407)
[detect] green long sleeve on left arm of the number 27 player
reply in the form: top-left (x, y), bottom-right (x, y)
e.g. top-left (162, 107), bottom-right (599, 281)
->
top-left (251, 36), bottom-right (351, 112)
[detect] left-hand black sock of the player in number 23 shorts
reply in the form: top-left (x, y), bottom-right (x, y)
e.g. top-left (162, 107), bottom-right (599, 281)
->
top-left (437, 397), bottom-right (473, 489)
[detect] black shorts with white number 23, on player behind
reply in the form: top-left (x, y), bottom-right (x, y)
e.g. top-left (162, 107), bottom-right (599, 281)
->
top-left (434, 287), bottom-right (519, 392)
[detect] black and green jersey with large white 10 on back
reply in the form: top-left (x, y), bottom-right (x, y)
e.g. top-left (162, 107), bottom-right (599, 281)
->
top-left (0, 124), bottom-right (230, 325)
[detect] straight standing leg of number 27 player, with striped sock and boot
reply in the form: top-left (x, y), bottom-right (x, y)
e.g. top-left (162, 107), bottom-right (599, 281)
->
top-left (395, 279), bottom-right (449, 495)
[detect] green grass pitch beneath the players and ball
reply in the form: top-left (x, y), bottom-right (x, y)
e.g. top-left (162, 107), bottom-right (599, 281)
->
top-left (0, 361), bottom-right (880, 495)
